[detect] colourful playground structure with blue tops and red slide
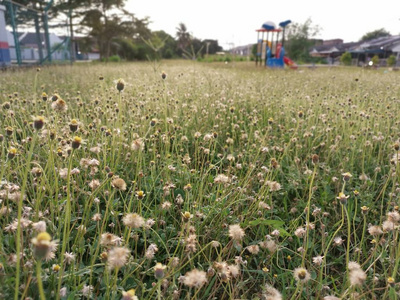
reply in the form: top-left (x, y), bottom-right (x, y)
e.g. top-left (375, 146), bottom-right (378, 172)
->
top-left (256, 20), bottom-right (297, 69)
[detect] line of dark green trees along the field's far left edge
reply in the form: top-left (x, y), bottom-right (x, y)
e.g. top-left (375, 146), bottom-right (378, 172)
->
top-left (7, 0), bottom-right (222, 60)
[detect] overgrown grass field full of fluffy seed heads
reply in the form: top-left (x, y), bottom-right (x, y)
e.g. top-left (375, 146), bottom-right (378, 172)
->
top-left (0, 61), bottom-right (400, 300)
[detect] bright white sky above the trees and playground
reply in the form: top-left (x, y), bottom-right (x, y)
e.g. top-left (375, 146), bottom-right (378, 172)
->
top-left (125, 0), bottom-right (400, 49)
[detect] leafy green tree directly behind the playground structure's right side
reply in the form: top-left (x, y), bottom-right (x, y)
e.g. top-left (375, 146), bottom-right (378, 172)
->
top-left (285, 18), bottom-right (320, 61)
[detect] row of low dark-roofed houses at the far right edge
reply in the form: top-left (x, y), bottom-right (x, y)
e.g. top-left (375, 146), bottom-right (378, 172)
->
top-left (310, 35), bottom-right (400, 65)
